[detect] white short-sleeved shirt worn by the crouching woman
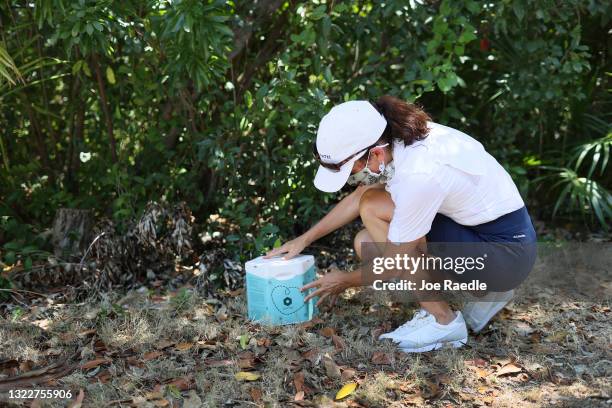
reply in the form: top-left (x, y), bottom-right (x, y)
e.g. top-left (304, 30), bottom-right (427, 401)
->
top-left (385, 122), bottom-right (525, 242)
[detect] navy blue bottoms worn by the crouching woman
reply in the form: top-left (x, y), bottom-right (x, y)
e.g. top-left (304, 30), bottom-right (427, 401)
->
top-left (426, 207), bottom-right (537, 292)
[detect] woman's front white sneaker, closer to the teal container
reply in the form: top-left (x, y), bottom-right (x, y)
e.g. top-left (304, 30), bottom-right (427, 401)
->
top-left (381, 311), bottom-right (467, 353)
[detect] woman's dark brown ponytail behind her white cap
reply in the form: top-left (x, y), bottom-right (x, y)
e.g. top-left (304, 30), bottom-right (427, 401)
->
top-left (372, 95), bottom-right (431, 146)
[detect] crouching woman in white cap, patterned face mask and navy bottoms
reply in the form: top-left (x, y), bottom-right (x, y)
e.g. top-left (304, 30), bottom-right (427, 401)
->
top-left (266, 96), bottom-right (536, 352)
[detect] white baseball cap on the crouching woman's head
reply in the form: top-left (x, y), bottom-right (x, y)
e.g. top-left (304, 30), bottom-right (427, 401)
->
top-left (314, 101), bottom-right (387, 193)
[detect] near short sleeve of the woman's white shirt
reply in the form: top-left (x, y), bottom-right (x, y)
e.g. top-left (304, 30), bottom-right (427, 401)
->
top-left (387, 174), bottom-right (445, 243)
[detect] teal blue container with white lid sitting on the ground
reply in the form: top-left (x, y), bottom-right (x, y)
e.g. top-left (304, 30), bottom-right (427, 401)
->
top-left (245, 255), bottom-right (317, 325)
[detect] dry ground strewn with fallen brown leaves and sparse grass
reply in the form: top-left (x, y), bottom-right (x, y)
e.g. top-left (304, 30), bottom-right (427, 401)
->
top-left (0, 252), bottom-right (612, 407)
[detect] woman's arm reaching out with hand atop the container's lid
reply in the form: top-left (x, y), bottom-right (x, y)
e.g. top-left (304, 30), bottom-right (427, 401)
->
top-left (266, 184), bottom-right (384, 259)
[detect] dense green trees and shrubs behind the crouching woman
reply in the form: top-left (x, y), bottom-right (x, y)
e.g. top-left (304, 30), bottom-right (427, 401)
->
top-left (0, 0), bottom-right (612, 274)
